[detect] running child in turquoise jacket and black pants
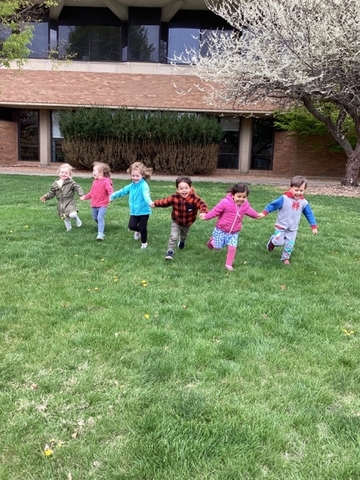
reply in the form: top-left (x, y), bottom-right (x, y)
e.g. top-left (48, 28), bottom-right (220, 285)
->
top-left (110, 162), bottom-right (152, 249)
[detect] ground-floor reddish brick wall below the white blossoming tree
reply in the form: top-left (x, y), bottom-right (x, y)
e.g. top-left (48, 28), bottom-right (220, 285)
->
top-left (272, 132), bottom-right (346, 177)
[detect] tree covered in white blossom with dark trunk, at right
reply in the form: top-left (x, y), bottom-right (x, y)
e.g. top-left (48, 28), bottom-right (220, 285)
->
top-left (187, 0), bottom-right (360, 185)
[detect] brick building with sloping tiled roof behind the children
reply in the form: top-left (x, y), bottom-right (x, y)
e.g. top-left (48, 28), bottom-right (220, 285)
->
top-left (0, 0), bottom-right (346, 177)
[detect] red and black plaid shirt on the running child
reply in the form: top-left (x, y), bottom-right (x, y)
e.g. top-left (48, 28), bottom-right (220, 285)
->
top-left (154, 192), bottom-right (209, 226)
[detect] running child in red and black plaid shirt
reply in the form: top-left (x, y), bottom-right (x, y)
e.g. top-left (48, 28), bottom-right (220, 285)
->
top-left (151, 176), bottom-right (209, 260)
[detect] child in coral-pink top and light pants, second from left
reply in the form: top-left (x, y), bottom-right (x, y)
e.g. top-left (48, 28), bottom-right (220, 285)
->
top-left (80, 162), bottom-right (114, 241)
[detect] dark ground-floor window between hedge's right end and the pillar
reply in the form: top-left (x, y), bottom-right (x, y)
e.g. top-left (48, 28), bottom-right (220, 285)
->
top-left (217, 117), bottom-right (240, 169)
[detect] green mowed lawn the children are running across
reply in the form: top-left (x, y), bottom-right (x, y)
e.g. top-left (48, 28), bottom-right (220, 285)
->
top-left (0, 175), bottom-right (360, 480)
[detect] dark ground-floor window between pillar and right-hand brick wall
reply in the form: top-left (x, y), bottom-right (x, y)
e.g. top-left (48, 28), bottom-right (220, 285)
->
top-left (250, 118), bottom-right (275, 170)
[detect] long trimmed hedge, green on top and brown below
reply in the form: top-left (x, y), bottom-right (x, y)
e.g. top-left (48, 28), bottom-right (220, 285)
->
top-left (59, 108), bottom-right (222, 175)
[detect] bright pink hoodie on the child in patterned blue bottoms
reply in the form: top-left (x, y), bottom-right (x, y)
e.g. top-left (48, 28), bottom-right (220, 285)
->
top-left (205, 193), bottom-right (259, 233)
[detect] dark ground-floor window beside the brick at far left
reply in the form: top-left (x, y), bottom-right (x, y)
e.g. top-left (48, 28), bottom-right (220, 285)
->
top-left (18, 110), bottom-right (39, 162)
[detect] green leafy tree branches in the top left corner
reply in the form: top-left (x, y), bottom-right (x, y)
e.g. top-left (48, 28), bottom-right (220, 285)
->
top-left (0, 0), bottom-right (57, 67)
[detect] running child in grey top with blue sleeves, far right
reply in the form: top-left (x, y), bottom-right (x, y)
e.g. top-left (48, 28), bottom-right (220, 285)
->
top-left (261, 175), bottom-right (318, 265)
